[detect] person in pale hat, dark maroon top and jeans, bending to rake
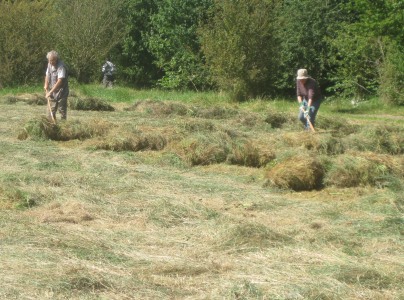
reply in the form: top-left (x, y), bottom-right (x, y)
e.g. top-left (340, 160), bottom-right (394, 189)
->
top-left (296, 69), bottom-right (323, 130)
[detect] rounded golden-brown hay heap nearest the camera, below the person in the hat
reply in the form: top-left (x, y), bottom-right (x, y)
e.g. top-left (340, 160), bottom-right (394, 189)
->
top-left (265, 155), bottom-right (325, 191)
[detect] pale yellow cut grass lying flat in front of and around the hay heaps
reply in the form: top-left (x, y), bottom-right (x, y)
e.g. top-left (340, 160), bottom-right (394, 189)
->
top-left (0, 95), bottom-right (404, 300)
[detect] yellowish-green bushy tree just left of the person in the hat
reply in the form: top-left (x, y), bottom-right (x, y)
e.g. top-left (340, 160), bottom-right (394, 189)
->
top-left (200, 0), bottom-right (279, 101)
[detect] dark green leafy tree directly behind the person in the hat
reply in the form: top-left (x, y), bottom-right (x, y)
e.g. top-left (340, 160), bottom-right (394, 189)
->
top-left (275, 0), bottom-right (346, 92)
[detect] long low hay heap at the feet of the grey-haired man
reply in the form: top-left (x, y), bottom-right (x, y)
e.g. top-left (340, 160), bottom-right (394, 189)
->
top-left (18, 116), bottom-right (112, 141)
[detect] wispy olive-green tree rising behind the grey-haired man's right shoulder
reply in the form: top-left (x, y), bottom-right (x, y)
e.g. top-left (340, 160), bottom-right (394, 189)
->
top-left (51, 0), bottom-right (124, 82)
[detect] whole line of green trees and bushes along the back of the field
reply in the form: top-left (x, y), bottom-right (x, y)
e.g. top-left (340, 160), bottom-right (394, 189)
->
top-left (0, 0), bottom-right (404, 105)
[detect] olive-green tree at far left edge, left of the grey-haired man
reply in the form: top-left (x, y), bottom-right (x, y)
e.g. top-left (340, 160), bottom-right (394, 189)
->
top-left (0, 1), bottom-right (51, 85)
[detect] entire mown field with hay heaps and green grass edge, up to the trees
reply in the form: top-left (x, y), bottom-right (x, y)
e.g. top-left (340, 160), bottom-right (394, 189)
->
top-left (0, 87), bottom-right (404, 299)
